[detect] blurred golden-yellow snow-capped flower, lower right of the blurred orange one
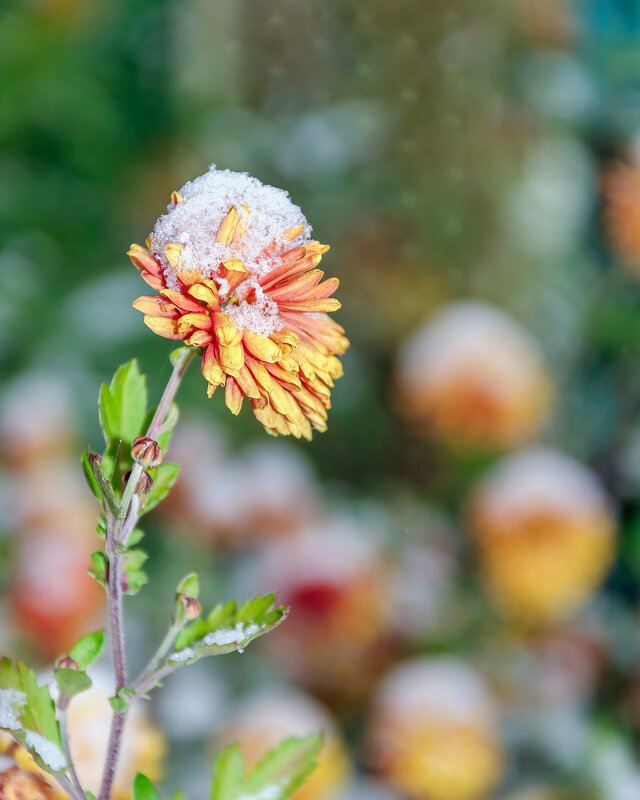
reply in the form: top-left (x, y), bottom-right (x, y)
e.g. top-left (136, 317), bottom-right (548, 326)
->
top-left (468, 448), bottom-right (616, 625)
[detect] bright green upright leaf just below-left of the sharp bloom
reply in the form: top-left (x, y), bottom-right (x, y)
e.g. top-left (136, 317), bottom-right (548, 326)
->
top-left (98, 358), bottom-right (147, 446)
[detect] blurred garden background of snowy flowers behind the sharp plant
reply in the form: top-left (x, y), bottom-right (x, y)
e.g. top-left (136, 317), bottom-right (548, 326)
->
top-left (0, 0), bottom-right (640, 800)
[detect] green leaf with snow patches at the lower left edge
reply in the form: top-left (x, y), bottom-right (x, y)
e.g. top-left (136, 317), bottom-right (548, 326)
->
top-left (0, 658), bottom-right (68, 774)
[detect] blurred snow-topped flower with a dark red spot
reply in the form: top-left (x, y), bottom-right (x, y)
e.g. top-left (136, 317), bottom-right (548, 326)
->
top-left (251, 515), bottom-right (394, 702)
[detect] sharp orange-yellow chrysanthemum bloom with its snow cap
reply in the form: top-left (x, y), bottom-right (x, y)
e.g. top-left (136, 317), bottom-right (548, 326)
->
top-left (129, 167), bottom-right (349, 439)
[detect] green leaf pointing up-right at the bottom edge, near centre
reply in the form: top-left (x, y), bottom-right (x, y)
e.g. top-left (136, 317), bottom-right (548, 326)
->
top-left (242, 734), bottom-right (323, 800)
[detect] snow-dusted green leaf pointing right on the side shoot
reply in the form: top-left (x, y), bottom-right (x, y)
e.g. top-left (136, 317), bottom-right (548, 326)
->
top-left (167, 594), bottom-right (289, 665)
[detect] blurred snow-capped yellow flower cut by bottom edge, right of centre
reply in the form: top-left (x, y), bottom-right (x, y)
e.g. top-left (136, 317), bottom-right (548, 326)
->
top-left (369, 658), bottom-right (504, 800)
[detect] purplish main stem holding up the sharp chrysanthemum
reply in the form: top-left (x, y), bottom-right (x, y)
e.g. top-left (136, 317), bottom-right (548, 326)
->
top-left (98, 348), bottom-right (197, 800)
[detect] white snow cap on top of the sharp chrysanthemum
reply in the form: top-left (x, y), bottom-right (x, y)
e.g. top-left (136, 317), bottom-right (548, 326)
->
top-left (150, 165), bottom-right (311, 284)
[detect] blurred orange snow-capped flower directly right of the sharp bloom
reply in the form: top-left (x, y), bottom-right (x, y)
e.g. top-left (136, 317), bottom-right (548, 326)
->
top-left (395, 301), bottom-right (551, 448)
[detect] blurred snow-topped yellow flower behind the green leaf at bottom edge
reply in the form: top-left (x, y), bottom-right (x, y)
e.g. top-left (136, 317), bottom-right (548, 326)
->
top-left (221, 689), bottom-right (350, 800)
